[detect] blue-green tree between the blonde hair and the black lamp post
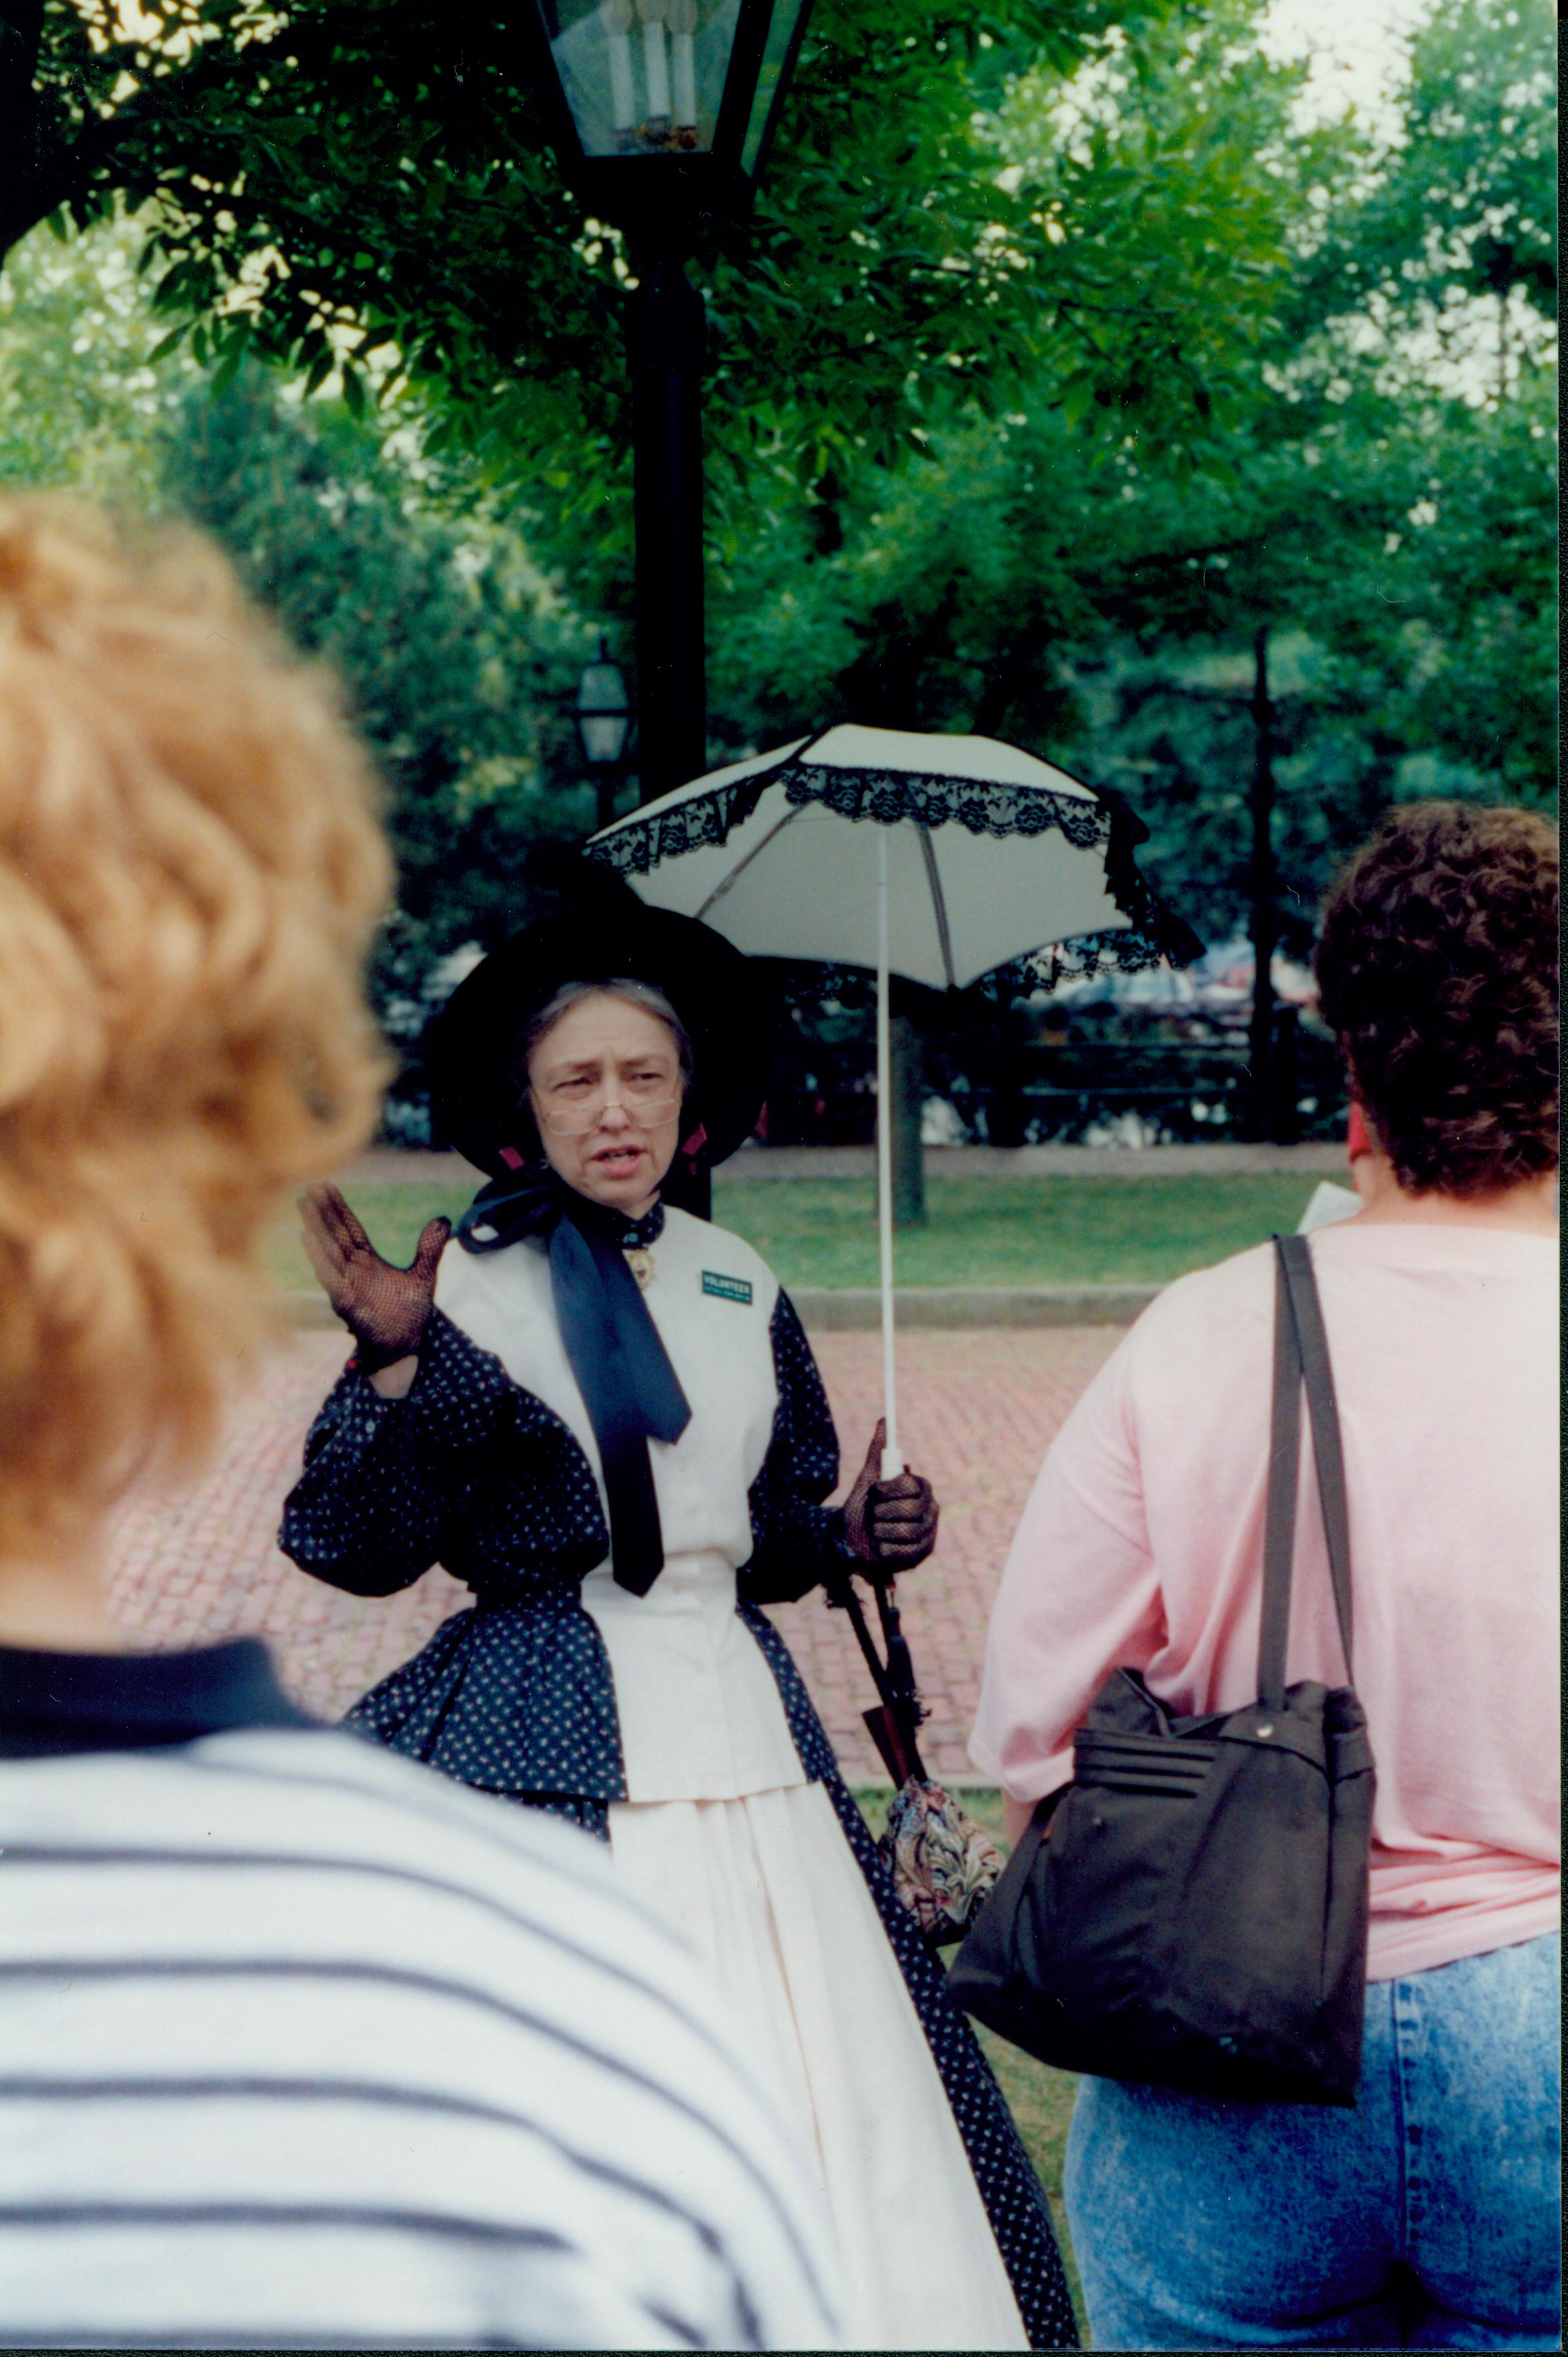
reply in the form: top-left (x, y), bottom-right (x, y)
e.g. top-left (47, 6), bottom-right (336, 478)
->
top-left (160, 370), bottom-right (592, 1023)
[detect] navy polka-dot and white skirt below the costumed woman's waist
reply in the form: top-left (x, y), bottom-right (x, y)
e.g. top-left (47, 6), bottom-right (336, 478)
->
top-left (352, 1558), bottom-right (1077, 2350)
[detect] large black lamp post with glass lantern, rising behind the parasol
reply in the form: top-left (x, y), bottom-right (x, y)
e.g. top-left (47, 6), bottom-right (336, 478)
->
top-left (523, 0), bottom-right (811, 802)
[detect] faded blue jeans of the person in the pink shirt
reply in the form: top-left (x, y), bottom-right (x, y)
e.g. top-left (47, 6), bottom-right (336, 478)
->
top-left (1066, 1933), bottom-right (1561, 2350)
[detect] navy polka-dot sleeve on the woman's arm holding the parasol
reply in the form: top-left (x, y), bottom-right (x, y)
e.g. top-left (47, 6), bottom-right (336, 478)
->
top-left (738, 1292), bottom-right (849, 1605)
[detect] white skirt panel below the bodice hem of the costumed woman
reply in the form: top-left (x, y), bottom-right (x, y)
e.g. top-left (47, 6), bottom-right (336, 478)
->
top-left (611, 1784), bottom-right (1028, 2350)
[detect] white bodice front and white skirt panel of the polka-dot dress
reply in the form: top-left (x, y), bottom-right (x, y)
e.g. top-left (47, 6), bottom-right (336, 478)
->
top-left (436, 1212), bottom-right (1028, 2350)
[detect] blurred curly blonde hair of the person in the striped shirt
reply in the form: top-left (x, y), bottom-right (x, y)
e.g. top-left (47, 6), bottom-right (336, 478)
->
top-left (0, 495), bottom-right (392, 1558)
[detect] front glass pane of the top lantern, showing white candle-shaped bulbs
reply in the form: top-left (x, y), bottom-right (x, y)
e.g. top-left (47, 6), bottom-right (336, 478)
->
top-left (537, 0), bottom-right (740, 156)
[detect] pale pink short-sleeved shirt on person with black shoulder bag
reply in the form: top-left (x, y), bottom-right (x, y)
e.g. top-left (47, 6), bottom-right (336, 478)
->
top-left (969, 1218), bottom-right (1559, 1980)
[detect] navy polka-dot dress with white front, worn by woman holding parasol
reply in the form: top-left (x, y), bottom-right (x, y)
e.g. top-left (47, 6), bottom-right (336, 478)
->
top-left (280, 1209), bottom-right (1077, 2350)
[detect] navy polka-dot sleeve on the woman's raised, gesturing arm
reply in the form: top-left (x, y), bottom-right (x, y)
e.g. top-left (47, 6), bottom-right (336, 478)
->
top-left (278, 1310), bottom-right (609, 1605)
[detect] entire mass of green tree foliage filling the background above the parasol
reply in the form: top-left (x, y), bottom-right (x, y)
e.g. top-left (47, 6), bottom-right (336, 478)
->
top-left (0, 0), bottom-right (1554, 976)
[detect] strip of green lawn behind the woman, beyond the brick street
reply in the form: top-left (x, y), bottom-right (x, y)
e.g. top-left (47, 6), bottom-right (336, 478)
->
top-left (266, 1171), bottom-right (1314, 1287)
